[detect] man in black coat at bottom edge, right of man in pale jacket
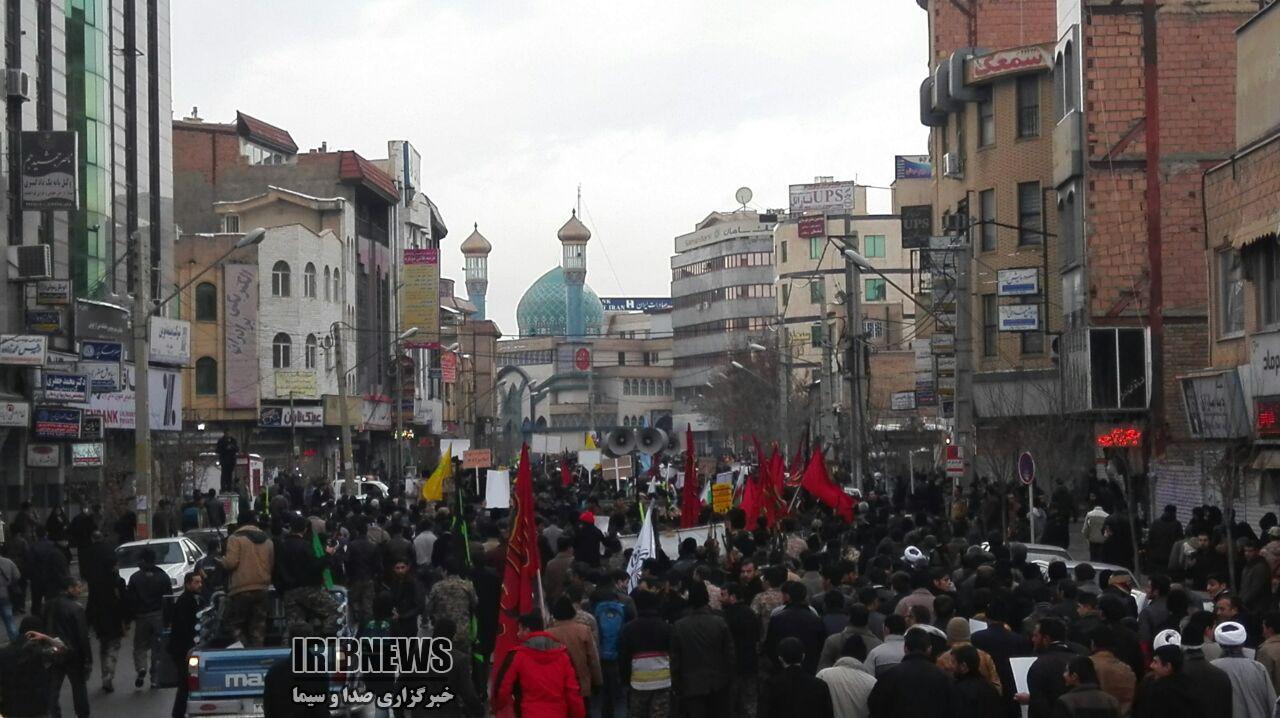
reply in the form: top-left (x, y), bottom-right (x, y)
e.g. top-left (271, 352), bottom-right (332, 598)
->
top-left (867, 630), bottom-right (955, 718)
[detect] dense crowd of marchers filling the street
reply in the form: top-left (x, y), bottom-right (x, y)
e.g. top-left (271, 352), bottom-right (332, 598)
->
top-left (0, 458), bottom-right (1280, 718)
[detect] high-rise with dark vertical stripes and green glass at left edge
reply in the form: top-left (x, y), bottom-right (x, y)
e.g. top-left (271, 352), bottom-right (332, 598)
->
top-left (0, 0), bottom-right (173, 508)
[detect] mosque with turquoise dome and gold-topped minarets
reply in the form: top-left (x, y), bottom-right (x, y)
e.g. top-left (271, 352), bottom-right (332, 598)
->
top-left (483, 211), bottom-right (672, 456)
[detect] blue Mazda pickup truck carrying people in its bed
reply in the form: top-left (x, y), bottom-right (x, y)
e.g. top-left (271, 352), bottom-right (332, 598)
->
top-left (184, 586), bottom-right (357, 718)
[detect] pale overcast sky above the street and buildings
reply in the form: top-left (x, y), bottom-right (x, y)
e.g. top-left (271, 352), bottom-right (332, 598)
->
top-left (172, 0), bottom-right (928, 335)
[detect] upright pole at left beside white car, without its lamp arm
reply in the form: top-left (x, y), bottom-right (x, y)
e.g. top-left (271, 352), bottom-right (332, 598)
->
top-left (132, 230), bottom-right (156, 538)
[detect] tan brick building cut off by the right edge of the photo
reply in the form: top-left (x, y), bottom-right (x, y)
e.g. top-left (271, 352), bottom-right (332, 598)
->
top-left (1203, 4), bottom-right (1280, 521)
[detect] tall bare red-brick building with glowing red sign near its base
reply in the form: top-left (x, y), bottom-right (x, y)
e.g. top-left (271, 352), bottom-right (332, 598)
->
top-left (1053, 0), bottom-right (1258, 518)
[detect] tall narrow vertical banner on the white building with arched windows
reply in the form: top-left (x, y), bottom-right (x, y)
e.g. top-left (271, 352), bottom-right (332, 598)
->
top-left (223, 264), bottom-right (259, 408)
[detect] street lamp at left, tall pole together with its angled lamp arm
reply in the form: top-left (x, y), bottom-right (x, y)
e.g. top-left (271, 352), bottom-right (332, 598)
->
top-left (131, 227), bottom-right (266, 536)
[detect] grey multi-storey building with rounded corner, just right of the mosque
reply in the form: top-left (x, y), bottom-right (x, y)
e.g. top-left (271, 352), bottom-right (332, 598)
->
top-left (671, 209), bottom-right (778, 449)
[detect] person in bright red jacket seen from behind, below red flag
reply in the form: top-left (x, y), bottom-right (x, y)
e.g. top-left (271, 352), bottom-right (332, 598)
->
top-left (493, 613), bottom-right (586, 718)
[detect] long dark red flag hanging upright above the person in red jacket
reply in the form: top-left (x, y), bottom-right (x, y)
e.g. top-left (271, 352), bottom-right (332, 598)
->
top-left (483, 444), bottom-right (543, 666)
